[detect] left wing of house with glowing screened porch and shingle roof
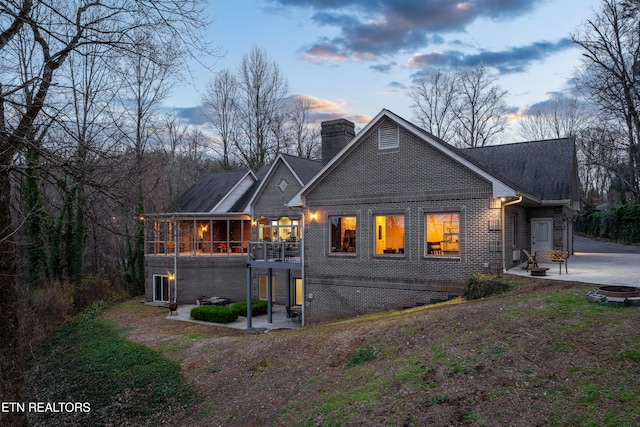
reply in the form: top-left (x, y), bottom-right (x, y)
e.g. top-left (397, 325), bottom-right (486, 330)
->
top-left (145, 169), bottom-right (266, 304)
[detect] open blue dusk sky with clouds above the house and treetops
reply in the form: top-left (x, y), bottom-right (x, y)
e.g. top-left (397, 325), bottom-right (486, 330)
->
top-left (165, 0), bottom-right (600, 139)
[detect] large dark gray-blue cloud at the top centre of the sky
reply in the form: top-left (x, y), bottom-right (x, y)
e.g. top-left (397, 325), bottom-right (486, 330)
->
top-left (271, 0), bottom-right (544, 61)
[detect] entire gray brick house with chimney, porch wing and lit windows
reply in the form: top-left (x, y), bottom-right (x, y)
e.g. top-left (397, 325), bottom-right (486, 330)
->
top-left (145, 110), bottom-right (578, 324)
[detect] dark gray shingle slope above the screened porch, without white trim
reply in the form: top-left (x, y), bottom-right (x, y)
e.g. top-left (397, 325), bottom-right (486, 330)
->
top-left (169, 169), bottom-right (248, 213)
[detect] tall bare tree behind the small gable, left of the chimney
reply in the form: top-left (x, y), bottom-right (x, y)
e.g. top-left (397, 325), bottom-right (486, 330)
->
top-left (236, 47), bottom-right (289, 170)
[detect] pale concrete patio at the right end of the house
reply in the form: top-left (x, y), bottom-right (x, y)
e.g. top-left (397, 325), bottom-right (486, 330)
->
top-left (507, 236), bottom-right (640, 287)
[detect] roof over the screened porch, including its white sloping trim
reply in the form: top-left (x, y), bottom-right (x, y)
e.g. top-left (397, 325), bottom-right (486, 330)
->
top-left (169, 169), bottom-right (257, 213)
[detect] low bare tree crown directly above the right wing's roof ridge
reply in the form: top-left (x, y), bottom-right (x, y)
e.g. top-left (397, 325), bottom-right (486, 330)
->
top-left (518, 96), bottom-right (587, 140)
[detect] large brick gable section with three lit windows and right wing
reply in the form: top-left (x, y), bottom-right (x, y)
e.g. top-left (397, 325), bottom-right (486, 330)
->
top-left (289, 110), bottom-right (578, 323)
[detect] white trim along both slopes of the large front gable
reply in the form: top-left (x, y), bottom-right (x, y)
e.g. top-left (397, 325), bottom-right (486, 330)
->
top-left (288, 109), bottom-right (520, 206)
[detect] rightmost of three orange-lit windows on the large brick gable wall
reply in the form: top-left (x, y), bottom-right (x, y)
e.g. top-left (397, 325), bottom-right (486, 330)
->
top-left (425, 213), bottom-right (460, 256)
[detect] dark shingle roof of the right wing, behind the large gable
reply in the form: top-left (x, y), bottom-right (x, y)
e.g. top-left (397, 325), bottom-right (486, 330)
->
top-left (463, 138), bottom-right (576, 201)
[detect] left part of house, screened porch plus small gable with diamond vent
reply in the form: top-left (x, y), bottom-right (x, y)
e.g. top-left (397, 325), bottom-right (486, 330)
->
top-left (145, 154), bottom-right (321, 305)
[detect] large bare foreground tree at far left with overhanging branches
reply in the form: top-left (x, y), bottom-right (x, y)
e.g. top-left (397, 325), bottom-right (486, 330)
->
top-left (0, 0), bottom-right (211, 425)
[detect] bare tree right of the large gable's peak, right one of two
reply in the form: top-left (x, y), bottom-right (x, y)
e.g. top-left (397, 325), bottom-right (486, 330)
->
top-left (453, 64), bottom-right (507, 148)
